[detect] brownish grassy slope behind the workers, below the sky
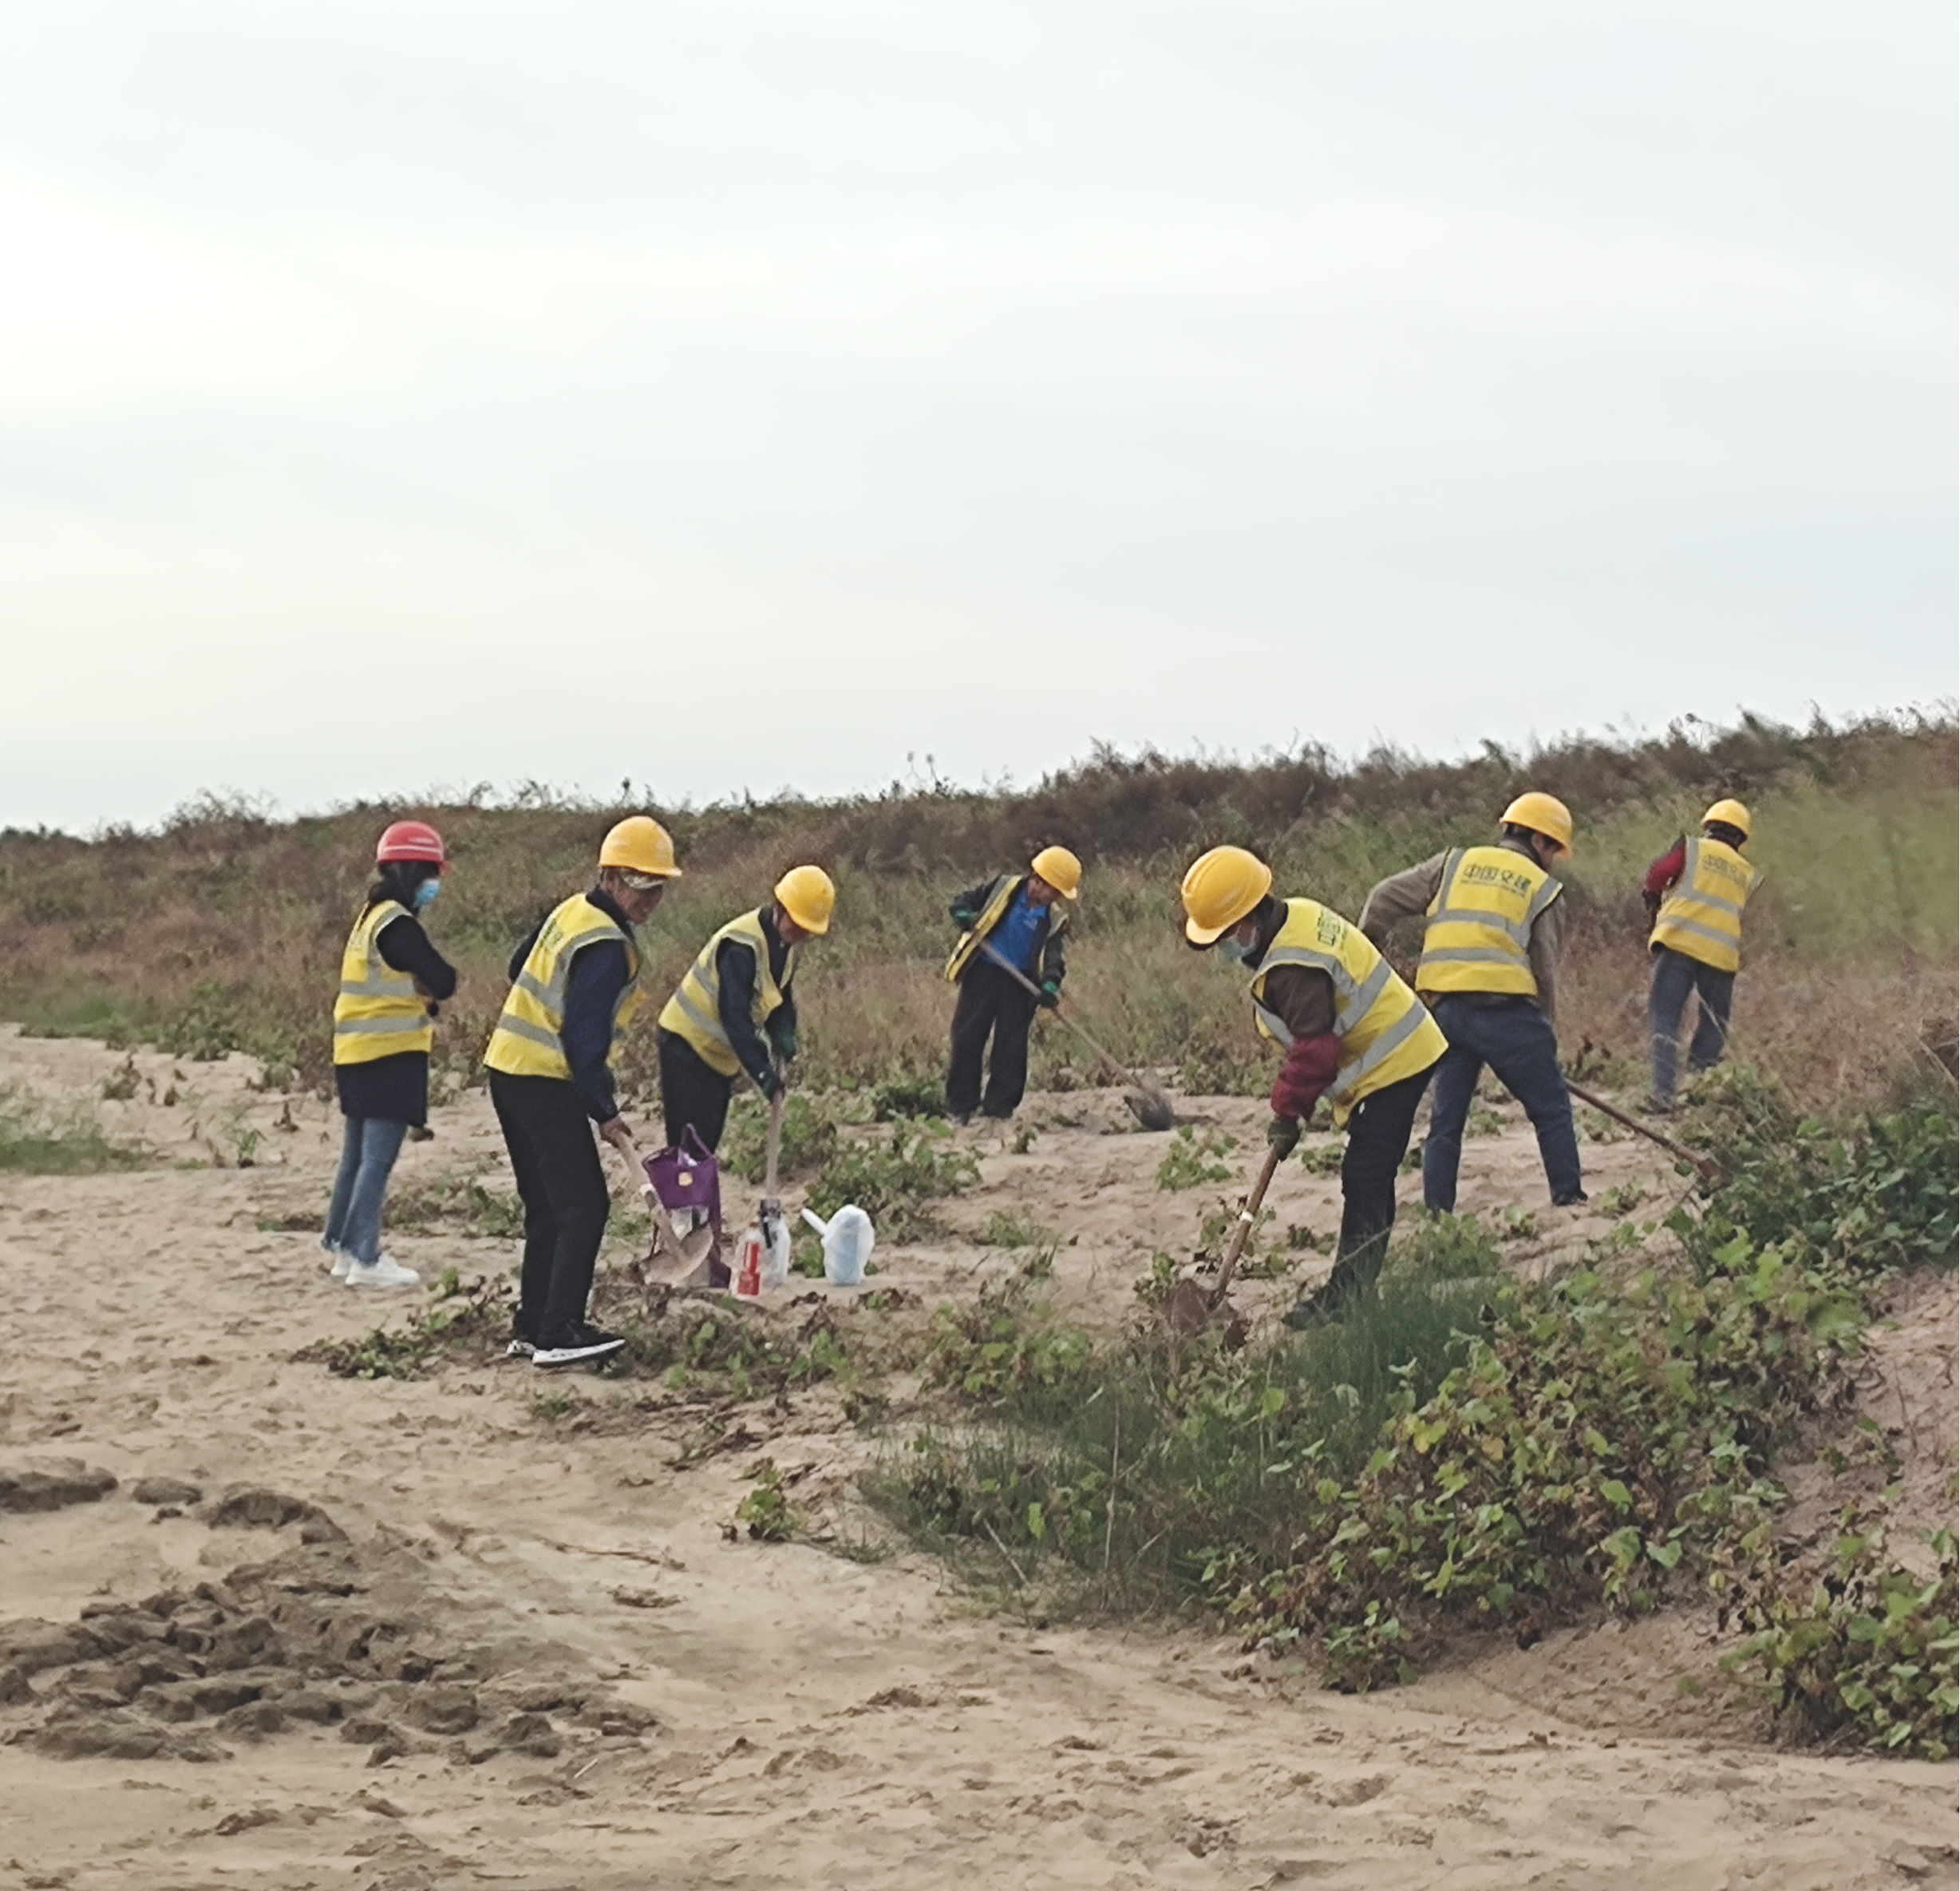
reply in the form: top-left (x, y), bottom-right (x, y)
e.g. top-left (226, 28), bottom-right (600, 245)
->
top-left (0, 721), bottom-right (1960, 1096)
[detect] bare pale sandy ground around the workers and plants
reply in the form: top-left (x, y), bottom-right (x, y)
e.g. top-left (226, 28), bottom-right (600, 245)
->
top-left (0, 1032), bottom-right (1960, 1891)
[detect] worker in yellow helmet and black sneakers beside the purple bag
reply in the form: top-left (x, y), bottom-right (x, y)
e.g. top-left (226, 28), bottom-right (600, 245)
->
top-left (484, 815), bottom-right (680, 1366)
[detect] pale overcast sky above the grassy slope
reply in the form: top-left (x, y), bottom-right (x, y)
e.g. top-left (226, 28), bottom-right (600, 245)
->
top-left (0, 0), bottom-right (1956, 829)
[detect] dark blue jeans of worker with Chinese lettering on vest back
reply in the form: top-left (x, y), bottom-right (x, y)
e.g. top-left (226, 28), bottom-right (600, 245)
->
top-left (1423, 992), bottom-right (1583, 1213)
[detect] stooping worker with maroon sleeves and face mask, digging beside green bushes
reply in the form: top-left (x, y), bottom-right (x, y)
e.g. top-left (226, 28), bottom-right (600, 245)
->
top-left (1182, 847), bottom-right (1448, 1327)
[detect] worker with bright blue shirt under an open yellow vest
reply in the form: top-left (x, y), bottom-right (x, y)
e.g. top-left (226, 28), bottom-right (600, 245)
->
top-left (946, 847), bottom-right (1082, 1123)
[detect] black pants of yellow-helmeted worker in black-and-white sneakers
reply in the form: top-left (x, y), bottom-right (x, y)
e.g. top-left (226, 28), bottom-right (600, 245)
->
top-left (490, 1070), bottom-right (611, 1340)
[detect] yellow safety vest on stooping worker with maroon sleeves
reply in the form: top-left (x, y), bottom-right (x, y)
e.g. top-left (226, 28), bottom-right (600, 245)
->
top-left (1252, 899), bottom-right (1450, 1129)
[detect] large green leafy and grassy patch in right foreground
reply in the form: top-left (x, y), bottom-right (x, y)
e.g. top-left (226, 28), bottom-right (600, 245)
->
top-left (868, 1076), bottom-right (1960, 1756)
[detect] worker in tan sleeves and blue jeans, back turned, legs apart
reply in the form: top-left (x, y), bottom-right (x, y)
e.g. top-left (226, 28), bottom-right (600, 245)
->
top-left (1360, 792), bottom-right (1586, 1213)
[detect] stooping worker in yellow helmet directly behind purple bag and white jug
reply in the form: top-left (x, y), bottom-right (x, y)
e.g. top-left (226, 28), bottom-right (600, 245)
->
top-left (658, 867), bottom-right (837, 1148)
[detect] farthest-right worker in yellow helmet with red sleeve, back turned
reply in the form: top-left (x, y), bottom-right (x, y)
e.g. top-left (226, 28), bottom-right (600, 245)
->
top-left (1642, 801), bottom-right (1762, 1115)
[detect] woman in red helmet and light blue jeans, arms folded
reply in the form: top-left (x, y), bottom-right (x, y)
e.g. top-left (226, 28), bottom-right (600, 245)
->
top-left (319, 821), bottom-right (456, 1288)
